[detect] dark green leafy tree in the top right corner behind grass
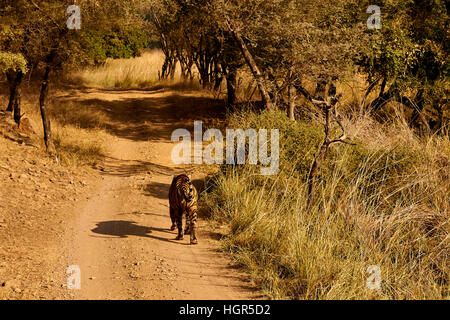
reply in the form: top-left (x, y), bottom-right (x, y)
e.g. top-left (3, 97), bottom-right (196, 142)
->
top-left (357, 0), bottom-right (450, 128)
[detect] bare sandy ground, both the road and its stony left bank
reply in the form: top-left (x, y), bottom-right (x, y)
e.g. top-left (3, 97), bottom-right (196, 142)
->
top-left (0, 89), bottom-right (262, 299)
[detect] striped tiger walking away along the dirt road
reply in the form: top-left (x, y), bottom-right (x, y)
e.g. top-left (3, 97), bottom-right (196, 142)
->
top-left (169, 174), bottom-right (198, 244)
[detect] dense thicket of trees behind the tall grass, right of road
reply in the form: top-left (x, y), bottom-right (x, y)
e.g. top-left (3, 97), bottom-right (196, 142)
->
top-left (148, 0), bottom-right (449, 128)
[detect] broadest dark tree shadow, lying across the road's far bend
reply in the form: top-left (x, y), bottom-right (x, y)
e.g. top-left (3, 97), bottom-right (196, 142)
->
top-left (55, 89), bottom-right (225, 141)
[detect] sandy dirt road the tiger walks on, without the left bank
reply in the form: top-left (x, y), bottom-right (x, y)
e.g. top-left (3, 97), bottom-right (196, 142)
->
top-left (59, 89), bottom-right (257, 299)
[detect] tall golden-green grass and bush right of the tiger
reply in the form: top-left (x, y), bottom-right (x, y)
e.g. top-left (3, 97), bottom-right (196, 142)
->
top-left (202, 112), bottom-right (450, 299)
